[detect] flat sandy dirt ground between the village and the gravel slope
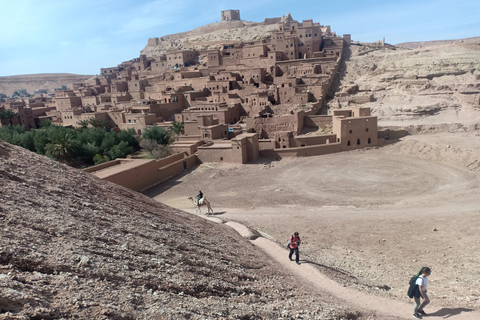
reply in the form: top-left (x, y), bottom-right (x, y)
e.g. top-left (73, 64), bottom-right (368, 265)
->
top-left (146, 133), bottom-right (480, 319)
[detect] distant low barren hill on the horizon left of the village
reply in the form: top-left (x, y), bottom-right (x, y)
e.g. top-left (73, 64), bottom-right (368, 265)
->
top-left (0, 73), bottom-right (92, 95)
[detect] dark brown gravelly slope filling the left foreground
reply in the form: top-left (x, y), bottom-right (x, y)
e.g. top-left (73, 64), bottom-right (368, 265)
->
top-left (0, 140), bottom-right (360, 319)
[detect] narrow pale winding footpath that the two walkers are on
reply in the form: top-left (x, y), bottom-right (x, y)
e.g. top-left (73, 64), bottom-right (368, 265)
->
top-left (203, 216), bottom-right (480, 320)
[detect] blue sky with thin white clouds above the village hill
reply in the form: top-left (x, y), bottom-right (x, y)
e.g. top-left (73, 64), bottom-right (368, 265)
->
top-left (0, 0), bottom-right (480, 76)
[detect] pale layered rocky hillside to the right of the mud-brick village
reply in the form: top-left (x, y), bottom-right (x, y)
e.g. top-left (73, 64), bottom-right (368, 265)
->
top-left (329, 37), bottom-right (480, 126)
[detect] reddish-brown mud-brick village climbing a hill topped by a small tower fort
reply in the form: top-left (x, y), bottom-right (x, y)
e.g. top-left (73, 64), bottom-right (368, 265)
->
top-left (0, 10), bottom-right (378, 163)
